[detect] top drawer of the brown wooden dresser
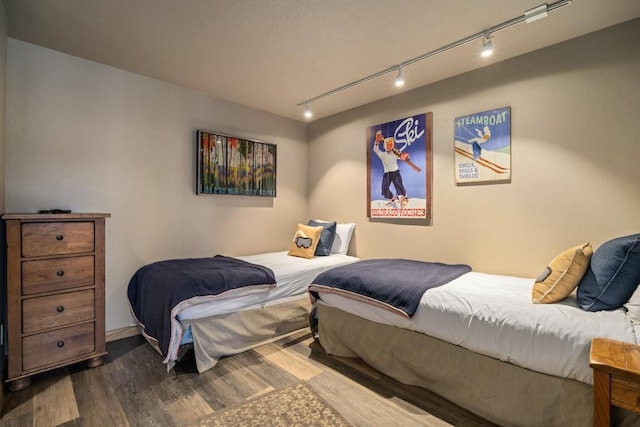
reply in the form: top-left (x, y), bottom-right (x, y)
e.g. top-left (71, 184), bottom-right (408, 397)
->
top-left (22, 222), bottom-right (95, 257)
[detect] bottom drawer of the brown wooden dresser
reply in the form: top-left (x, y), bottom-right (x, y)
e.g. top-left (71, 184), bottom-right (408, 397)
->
top-left (22, 323), bottom-right (95, 371)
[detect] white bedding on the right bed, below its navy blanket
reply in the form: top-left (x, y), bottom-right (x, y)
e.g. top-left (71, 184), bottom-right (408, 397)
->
top-left (320, 272), bottom-right (637, 384)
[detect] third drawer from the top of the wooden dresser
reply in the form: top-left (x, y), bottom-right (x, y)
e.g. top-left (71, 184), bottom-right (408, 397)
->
top-left (22, 289), bottom-right (95, 334)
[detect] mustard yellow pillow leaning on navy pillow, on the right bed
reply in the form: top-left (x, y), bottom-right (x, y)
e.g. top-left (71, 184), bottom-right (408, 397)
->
top-left (531, 243), bottom-right (593, 304)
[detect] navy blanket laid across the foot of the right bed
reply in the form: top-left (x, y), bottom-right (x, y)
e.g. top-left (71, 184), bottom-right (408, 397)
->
top-left (309, 259), bottom-right (471, 317)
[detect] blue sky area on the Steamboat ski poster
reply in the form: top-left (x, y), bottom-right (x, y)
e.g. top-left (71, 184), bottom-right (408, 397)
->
top-left (454, 107), bottom-right (511, 152)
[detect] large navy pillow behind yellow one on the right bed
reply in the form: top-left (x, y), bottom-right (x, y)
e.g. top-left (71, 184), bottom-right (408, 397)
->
top-left (577, 234), bottom-right (640, 311)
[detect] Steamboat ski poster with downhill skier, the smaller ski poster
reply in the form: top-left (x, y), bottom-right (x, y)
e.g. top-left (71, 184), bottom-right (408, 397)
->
top-left (454, 107), bottom-right (511, 185)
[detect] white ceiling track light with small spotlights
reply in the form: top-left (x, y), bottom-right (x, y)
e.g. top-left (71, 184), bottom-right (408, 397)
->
top-left (297, 0), bottom-right (571, 118)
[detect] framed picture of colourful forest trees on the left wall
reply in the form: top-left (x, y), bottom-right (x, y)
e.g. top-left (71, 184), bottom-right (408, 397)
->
top-left (196, 130), bottom-right (277, 197)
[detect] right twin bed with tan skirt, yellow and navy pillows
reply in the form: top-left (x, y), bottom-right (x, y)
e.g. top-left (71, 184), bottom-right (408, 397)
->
top-left (309, 234), bottom-right (640, 427)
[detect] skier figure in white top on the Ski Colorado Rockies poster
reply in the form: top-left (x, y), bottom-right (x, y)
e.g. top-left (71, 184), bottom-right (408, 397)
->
top-left (373, 130), bottom-right (409, 207)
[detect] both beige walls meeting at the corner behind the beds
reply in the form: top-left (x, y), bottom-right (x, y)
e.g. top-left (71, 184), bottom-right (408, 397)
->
top-left (5, 20), bottom-right (640, 330)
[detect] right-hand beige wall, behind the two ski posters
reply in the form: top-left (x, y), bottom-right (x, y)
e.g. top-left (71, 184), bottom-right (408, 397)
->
top-left (309, 20), bottom-right (640, 277)
